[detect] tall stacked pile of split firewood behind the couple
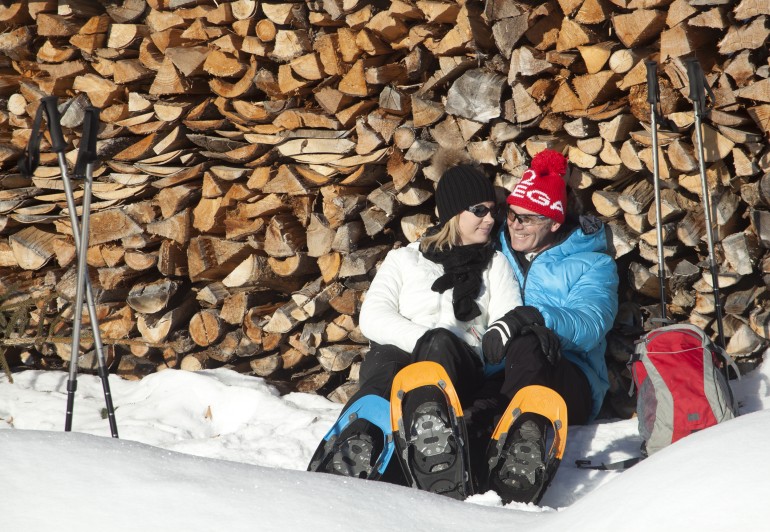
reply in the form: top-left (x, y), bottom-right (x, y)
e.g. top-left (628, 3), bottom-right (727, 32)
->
top-left (0, 0), bottom-right (770, 412)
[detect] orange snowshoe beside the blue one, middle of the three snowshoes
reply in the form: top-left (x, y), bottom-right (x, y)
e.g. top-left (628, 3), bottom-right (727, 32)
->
top-left (390, 362), bottom-right (473, 500)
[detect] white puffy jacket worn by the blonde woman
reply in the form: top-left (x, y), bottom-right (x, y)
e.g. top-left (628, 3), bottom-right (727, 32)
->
top-left (359, 242), bottom-right (521, 360)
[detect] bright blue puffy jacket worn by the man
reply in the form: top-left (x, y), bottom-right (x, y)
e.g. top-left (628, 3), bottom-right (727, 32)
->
top-left (498, 217), bottom-right (618, 419)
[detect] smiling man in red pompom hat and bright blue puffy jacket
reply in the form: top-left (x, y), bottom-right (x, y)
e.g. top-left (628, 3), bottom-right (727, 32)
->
top-left (483, 150), bottom-right (618, 500)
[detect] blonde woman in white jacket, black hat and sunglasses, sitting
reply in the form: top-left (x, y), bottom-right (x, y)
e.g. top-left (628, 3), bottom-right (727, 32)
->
top-left (309, 164), bottom-right (521, 496)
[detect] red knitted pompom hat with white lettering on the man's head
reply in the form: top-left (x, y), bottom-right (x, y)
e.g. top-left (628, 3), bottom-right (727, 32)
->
top-left (508, 150), bottom-right (567, 223)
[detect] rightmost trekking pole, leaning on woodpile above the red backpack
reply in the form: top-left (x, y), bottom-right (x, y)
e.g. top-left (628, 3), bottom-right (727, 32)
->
top-left (685, 58), bottom-right (726, 349)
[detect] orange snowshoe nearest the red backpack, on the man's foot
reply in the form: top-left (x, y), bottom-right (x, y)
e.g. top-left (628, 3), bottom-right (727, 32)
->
top-left (487, 386), bottom-right (567, 504)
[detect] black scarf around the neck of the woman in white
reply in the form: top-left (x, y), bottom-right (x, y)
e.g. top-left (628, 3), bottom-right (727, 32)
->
top-left (423, 243), bottom-right (495, 321)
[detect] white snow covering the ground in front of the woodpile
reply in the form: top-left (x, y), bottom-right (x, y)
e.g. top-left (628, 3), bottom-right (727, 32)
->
top-left (0, 362), bottom-right (770, 532)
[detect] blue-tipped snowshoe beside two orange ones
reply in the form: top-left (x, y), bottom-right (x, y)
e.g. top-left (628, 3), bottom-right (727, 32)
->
top-left (307, 395), bottom-right (395, 480)
